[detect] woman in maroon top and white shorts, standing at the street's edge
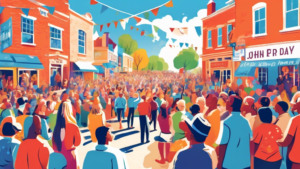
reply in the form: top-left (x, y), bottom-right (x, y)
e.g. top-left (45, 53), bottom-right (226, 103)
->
top-left (154, 102), bottom-right (172, 164)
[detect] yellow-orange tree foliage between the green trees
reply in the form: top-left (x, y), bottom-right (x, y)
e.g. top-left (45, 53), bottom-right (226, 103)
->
top-left (132, 49), bottom-right (149, 70)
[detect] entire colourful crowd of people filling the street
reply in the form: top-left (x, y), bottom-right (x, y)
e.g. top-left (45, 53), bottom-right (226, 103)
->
top-left (0, 72), bottom-right (300, 169)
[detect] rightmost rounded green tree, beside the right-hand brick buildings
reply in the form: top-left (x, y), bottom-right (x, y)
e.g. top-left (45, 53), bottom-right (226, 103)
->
top-left (173, 48), bottom-right (199, 70)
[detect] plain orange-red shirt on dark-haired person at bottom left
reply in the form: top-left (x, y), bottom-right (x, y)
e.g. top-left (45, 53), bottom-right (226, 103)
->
top-left (15, 139), bottom-right (49, 169)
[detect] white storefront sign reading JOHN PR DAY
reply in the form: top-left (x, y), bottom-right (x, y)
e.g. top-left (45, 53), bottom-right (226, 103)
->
top-left (245, 43), bottom-right (300, 61)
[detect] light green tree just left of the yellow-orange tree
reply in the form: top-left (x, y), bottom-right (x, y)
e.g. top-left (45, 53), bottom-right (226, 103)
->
top-left (118, 34), bottom-right (138, 55)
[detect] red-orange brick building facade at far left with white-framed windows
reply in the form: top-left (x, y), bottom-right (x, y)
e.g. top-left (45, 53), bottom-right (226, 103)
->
top-left (0, 0), bottom-right (70, 86)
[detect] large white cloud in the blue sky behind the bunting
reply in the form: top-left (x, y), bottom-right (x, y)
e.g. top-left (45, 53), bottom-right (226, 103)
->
top-left (137, 9), bottom-right (207, 71)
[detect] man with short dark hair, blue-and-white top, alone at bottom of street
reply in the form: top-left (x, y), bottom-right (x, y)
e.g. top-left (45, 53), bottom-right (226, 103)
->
top-left (83, 126), bottom-right (129, 169)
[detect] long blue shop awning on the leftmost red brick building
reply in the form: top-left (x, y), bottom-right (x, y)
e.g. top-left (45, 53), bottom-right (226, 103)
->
top-left (0, 53), bottom-right (44, 69)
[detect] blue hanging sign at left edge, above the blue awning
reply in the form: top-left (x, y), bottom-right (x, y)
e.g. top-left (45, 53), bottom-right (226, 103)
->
top-left (0, 18), bottom-right (12, 52)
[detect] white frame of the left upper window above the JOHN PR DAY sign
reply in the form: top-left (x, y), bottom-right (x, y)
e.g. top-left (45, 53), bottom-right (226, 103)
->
top-left (252, 2), bottom-right (268, 37)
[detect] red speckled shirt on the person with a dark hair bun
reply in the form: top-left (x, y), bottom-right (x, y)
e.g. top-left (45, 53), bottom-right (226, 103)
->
top-left (253, 123), bottom-right (283, 162)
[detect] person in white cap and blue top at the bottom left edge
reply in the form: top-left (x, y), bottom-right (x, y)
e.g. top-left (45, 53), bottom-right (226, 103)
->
top-left (0, 116), bottom-right (22, 169)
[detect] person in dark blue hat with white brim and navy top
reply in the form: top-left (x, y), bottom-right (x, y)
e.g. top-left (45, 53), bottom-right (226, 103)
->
top-left (174, 113), bottom-right (217, 169)
